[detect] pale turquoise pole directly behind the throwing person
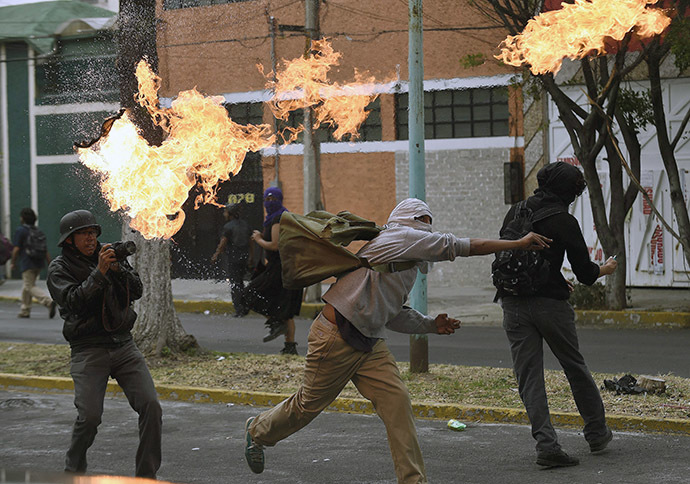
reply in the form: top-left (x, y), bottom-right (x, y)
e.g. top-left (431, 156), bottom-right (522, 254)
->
top-left (407, 0), bottom-right (429, 373)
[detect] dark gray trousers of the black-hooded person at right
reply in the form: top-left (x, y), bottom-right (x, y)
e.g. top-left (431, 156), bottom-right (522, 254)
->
top-left (501, 296), bottom-right (607, 452)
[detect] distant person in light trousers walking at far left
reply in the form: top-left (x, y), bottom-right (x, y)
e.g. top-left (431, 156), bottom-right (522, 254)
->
top-left (10, 207), bottom-right (55, 319)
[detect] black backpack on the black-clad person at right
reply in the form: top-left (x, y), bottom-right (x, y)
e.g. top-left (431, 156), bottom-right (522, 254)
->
top-left (491, 200), bottom-right (563, 296)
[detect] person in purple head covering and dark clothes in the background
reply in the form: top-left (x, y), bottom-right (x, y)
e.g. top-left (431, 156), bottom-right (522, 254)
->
top-left (243, 187), bottom-right (302, 355)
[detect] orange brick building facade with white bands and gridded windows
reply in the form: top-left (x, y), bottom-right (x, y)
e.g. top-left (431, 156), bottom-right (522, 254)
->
top-left (157, 0), bottom-right (523, 285)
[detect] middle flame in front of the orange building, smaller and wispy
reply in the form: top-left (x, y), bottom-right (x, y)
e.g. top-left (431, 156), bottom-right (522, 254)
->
top-left (259, 39), bottom-right (378, 141)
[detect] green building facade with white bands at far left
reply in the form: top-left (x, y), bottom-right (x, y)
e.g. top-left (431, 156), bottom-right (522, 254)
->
top-left (0, 1), bottom-right (121, 272)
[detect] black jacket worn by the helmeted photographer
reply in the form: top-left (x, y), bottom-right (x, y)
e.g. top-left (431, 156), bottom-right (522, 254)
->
top-left (47, 244), bottom-right (143, 349)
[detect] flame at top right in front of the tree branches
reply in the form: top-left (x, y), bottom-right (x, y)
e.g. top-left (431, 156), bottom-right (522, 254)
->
top-left (496, 0), bottom-right (671, 75)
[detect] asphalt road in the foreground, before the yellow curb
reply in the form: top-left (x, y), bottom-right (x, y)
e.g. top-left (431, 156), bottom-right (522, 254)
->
top-left (0, 391), bottom-right (690, 484)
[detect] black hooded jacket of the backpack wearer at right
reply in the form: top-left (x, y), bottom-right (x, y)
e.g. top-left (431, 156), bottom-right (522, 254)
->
top-left (496, 163), bottom-right (599, 299)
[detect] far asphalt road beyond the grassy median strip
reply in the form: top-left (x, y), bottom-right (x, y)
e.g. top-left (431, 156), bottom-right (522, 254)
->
top-left (0, 301), bottom-right (690, 377)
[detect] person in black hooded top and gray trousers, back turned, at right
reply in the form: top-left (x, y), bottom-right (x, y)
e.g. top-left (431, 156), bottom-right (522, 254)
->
top-left (496, 162), bottom-right (617, 467)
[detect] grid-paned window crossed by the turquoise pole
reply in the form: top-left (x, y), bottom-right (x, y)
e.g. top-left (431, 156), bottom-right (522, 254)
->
top-left (395, 87), bottom-right (510, 140)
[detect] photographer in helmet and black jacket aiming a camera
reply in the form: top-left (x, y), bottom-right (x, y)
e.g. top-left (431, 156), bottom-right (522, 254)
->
top-left (48, 210), bottom-right (162, 479)
